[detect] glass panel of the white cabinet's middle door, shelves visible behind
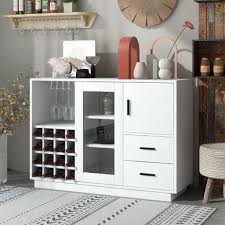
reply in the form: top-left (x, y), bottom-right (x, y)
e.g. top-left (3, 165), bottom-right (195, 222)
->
top-left (83, 92), bottom-right (114, 175)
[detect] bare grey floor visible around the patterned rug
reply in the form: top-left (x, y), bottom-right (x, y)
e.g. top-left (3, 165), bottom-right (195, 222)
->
top-left (6, 170), bottom-right (225, 225)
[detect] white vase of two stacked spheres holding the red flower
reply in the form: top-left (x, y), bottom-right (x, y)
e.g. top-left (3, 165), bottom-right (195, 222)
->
top-left (159, 58), bottom-right (173, 79)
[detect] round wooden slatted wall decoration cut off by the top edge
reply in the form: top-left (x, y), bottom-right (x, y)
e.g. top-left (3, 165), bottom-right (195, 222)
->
top-left (118, 0), bottom-right (177, 27)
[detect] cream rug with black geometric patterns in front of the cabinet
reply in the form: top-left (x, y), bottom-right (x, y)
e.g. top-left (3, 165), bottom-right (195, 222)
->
top-left (0, 186), bottom-right (214, 225)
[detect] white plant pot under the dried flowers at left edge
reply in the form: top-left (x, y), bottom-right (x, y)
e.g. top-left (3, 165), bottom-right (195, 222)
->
top-left (0, 135), bottom-right (7, 184)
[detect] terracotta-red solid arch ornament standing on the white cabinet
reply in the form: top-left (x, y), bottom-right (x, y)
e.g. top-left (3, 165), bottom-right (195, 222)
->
top-left (118, 37), bottom-right (140, 79)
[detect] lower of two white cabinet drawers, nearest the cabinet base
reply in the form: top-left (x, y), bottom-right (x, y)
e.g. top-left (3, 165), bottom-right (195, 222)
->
top-left (124, 162), bottom-right (174, 191)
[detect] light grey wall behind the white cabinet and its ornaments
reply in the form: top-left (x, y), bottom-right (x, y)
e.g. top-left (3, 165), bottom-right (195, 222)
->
top-left (0, 0), bottom-right (198, 171)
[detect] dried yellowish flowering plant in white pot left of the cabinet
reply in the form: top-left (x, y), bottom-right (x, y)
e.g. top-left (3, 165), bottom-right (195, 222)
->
top-left (0, 71), bottom-right (37, 184)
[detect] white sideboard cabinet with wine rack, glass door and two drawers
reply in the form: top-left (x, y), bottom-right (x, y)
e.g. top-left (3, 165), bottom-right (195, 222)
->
top-left (30, 78), bottom-right (193, 202)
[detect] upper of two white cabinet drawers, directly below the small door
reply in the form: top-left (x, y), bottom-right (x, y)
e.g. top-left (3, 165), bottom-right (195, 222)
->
top-left (124, 135), bottom-right (174, 163)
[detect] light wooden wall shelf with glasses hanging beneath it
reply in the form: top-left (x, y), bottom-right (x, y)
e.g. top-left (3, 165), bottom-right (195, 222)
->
top-left (3, 12), bottom-right (97, 30)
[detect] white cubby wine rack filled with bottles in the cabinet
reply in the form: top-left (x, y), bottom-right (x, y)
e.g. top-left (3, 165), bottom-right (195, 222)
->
top-left (32, 127), bottom-right (77, 181)
